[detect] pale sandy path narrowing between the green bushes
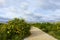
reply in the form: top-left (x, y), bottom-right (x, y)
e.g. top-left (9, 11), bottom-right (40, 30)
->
top-left (24, 27), bottom-right (57, 40)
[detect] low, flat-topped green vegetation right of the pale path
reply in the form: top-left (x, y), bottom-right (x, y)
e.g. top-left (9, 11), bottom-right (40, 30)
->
top-left (31, 22), bottom-right (60, 40)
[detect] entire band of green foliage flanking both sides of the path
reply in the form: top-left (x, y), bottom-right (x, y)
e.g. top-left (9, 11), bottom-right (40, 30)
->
top-left (0, 18), bottom-right (60, 40)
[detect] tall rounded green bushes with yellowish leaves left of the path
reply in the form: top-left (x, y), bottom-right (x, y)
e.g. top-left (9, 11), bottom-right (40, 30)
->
top-left (0, 18), bottom-right (30, 40)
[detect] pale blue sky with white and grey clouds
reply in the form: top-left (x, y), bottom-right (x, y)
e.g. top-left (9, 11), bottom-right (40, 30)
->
top-left (0, 0), bottom-right (60, 22)
